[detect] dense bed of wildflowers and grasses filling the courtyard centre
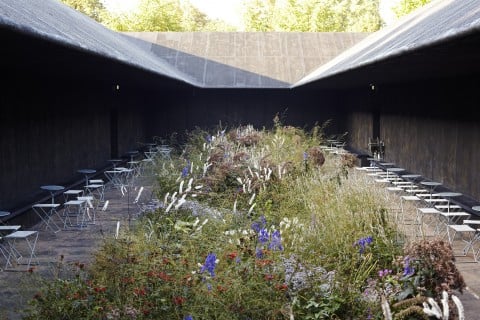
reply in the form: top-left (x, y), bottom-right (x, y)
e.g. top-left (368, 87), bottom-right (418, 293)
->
top-left (27, 120), bottom-right (465, 319)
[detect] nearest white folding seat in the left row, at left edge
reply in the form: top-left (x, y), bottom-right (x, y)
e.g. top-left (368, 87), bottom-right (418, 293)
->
top-left (4, 231), bottom-right (39, 270)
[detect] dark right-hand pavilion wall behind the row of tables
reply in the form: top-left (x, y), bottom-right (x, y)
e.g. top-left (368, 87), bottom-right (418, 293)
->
top-left (345, 76), bottom-right (480, 200)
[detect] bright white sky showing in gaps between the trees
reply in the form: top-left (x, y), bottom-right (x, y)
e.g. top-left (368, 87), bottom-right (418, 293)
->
top-left (103, 0), bottom-right (398, 27)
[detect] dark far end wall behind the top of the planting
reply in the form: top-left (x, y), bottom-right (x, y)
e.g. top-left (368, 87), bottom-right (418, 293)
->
top-left (144, 87), bottom-right (345, 137)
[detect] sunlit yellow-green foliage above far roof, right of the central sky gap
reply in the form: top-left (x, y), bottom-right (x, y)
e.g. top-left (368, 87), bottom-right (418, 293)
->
top-left (244, 0), bottom-right (382, 32)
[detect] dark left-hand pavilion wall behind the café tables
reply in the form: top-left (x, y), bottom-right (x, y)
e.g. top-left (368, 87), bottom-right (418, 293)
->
top-left (0, 70), bottom-right (148, 212)
